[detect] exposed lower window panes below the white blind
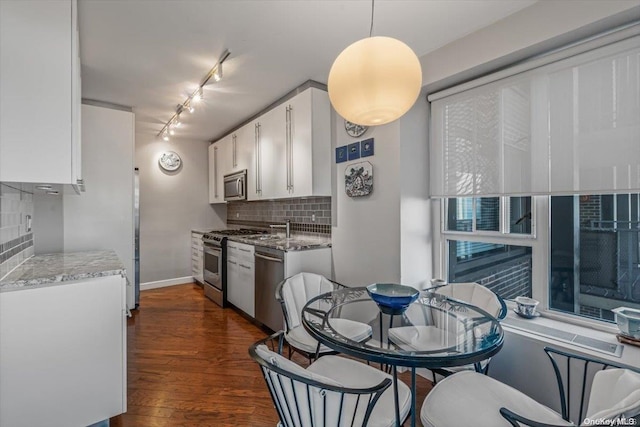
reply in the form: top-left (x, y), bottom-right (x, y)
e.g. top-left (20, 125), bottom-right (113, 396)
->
top-left (442, 193), bottom-right (640, 322)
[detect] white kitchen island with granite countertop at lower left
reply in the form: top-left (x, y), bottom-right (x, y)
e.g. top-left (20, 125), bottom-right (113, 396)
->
top-left (0, 251), bottom-right (127, 427)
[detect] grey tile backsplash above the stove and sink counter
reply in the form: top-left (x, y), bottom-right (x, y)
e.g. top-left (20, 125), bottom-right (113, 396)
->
top-left (227, 197), bottom-right (331, 235)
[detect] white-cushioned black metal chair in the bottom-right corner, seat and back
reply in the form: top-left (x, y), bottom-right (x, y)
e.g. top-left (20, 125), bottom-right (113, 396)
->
top-left (420, 348), bottom-right (640, 427)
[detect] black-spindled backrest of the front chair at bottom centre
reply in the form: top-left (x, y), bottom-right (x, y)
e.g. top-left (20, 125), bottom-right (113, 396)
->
top-left (249, 331), bottom-right (391, 427)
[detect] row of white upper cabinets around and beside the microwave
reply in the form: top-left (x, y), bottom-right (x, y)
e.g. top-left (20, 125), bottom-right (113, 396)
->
top-left (214, 88), bottom-right (331, 203)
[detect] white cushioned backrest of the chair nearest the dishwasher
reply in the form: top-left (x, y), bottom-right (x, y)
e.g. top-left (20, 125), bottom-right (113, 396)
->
top-left (276, 272), bottom-right (342, 329)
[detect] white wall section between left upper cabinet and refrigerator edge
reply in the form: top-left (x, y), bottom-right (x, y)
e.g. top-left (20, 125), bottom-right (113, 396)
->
top-left (63, 105), bottom-right (135, 308)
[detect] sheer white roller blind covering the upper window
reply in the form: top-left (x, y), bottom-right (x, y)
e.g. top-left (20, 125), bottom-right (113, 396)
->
top-left (430, 32), bottom-right (640, 197)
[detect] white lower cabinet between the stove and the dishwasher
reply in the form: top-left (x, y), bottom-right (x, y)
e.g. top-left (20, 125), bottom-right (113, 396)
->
top-left (226, 242), bottom-right (255, 317)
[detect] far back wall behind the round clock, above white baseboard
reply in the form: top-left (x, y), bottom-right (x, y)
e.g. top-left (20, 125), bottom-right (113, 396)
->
top-left (136, 133), bottom-right (227, 284)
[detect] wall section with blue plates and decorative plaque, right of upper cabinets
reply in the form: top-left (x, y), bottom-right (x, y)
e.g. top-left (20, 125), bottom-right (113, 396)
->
top-left (331, 116), bottom-right (400, 286)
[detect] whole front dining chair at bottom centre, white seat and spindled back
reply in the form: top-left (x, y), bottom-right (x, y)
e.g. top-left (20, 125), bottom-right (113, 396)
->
top-left (249, 331), bottom-right (411, 427)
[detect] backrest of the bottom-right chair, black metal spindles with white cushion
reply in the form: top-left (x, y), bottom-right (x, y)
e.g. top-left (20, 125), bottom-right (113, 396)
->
top-left (544, 347), bottom-right (640, 425)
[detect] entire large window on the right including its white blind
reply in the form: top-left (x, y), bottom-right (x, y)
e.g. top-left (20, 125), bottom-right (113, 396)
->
top-left (428, 30), bottom-right (640, 321)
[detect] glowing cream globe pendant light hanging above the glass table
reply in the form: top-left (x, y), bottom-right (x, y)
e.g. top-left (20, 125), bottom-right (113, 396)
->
top-left (327, 1), bottom-right (422, 126)
